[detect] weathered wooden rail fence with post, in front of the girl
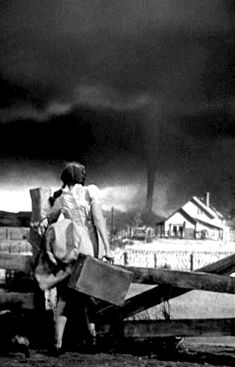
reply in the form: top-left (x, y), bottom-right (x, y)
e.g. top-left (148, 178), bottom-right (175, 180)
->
top-left (0, 189), bottom-right (235, 344)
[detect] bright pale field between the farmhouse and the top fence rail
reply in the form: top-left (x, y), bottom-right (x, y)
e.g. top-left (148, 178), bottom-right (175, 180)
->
top-left (114, 238), bottom-right (235, 270)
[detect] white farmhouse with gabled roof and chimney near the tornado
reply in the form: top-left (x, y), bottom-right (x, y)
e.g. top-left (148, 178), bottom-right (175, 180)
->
top-left (157, 193), bottom-right (229, 241)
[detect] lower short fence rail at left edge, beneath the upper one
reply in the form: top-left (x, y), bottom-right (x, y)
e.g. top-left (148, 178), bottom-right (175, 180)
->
top-left (0, 291), bottom-right (34, 309)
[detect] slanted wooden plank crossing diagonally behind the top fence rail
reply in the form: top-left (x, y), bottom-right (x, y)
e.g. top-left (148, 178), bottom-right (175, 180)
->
top-left (97, 254), bottom-right (235, 321)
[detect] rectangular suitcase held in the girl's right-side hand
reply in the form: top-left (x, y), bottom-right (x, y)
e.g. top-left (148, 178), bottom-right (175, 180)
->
top-left (68, 254), bottom-right (133, 306)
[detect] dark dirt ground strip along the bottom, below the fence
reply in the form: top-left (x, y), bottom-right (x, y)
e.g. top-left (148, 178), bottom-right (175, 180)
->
top-left (0, 338), bottom-right (235, 367)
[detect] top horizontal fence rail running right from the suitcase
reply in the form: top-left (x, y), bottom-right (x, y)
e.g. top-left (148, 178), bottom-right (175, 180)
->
top-left (128, 267), bottom-right (235, 294)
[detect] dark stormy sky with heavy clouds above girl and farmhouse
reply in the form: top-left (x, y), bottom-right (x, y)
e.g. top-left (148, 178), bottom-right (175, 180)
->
top-left (0, 0), bottom-right (235, 214)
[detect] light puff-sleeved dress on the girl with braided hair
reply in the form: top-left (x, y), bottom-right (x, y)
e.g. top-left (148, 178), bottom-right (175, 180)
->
top-left (46, 184), bottom-right (103, 264)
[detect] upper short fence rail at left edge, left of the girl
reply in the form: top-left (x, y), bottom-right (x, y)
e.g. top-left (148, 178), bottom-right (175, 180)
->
top-left (0, 253), bottom-right (32, 273)
